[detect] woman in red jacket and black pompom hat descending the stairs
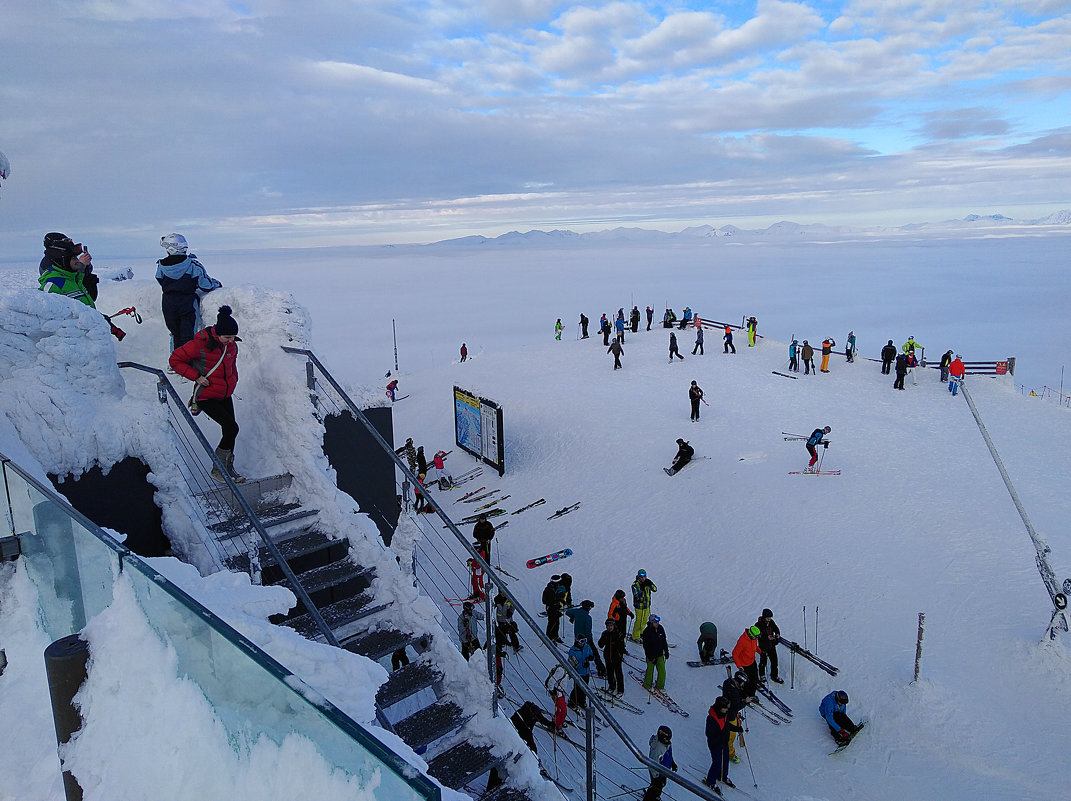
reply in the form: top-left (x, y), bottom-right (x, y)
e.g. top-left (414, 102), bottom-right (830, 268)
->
top-left (168, 306), bottom-right (245, 484)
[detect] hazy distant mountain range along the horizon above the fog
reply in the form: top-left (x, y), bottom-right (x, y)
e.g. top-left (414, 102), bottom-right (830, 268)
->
top-left (429, 209), bottom-right (1071, 246)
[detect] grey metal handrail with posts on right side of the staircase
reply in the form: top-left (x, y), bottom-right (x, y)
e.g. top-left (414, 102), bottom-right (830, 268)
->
top-left (281, 345), bottom-right (721, 801)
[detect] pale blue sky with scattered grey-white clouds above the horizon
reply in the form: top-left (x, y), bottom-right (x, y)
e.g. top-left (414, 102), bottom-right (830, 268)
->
top-left (0, 0), bottom-right (1071, 251)
